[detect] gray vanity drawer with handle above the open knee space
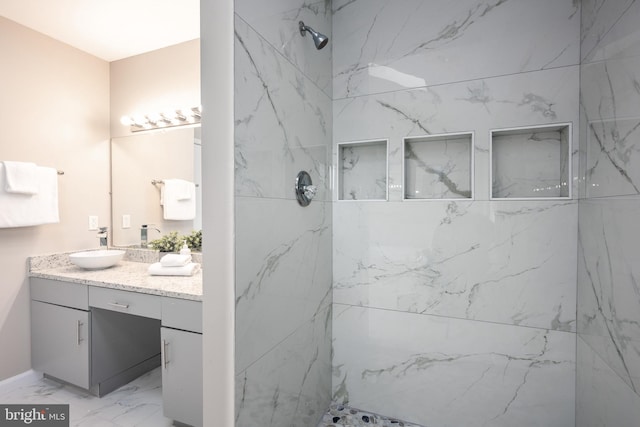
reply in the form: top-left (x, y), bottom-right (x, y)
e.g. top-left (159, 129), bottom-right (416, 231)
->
top-left (89, 286), bottom-right (161, 319)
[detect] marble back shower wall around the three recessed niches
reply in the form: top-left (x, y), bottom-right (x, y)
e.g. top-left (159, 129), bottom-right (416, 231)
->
top-left (333, 0), bottom-right (580, 427)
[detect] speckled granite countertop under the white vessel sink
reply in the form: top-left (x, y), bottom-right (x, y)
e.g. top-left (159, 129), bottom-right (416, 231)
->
top-left (29, 249), bottom-right (202, 301)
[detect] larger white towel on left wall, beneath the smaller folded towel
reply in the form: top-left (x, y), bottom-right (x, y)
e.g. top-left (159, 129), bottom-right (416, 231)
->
top-left (0, 163), bottom-right (60, 228)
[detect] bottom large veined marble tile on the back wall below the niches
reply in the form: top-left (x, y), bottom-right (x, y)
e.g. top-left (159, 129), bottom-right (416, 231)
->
top-left (333, 304), bottom-right (575, 427)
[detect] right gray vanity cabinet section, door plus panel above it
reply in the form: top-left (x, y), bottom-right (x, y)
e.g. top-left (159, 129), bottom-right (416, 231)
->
top-left (161, 298), bottom-right (202, 427)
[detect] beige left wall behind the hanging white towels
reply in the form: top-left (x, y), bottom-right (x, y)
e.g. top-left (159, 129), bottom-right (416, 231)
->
top-left (0, 17), bottom-right (110, 380)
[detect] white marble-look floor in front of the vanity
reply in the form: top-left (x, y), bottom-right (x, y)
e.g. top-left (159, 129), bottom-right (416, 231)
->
top-left (0, 368), bottom-right (173, 427)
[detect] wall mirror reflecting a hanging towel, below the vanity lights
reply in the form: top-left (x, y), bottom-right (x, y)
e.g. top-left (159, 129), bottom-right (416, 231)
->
top-left (111, 127), bottom-right (202, 247)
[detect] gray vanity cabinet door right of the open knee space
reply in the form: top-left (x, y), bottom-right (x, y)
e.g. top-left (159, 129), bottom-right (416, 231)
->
top-left (161, 328), bottom-right (202, 427)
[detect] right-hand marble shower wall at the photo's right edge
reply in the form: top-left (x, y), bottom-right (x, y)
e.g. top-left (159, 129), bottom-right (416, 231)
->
top-left (577, 0), bottom-right (640, 427)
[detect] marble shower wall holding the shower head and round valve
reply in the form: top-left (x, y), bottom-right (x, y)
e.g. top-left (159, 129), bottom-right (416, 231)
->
top-left (234, 0), bottom-right (332, 427)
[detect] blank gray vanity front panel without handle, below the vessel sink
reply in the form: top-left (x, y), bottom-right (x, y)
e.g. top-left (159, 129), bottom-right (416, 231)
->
top-left (29, 277), bottom-right (89, 310)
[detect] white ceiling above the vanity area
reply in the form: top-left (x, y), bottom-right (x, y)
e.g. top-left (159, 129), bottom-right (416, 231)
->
top-left (0, 0), bottom-right (200, 62)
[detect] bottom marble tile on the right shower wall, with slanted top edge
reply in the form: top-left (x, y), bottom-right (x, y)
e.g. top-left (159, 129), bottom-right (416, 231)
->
top-left (576, 337), bottom-right (640, 427)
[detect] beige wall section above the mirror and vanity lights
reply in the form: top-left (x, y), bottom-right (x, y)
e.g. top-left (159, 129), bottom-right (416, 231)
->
top-left (111, 40), bottom-right (200, 138)
